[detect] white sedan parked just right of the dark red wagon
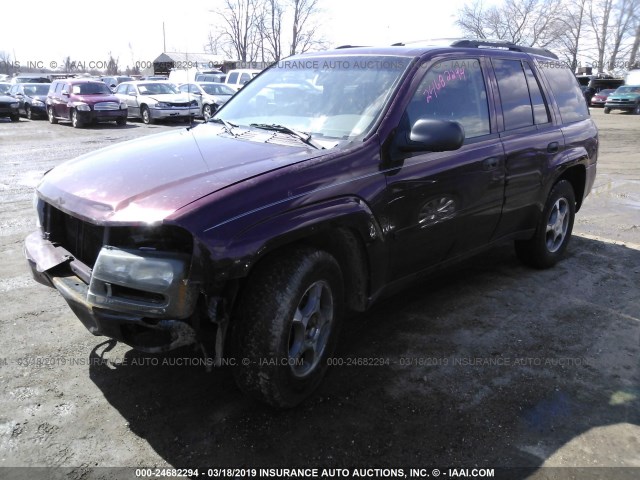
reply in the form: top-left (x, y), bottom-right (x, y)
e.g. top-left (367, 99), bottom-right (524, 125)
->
top-left (116, 81), bottom-right (199, 124)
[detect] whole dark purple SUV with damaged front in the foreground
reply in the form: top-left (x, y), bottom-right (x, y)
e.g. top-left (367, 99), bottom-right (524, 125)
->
top-left (25, 40), bottom-right (598, 407)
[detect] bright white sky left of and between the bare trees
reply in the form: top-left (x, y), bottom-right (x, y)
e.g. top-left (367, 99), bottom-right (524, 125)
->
top-left (0, 0), bottom-right (470, 68)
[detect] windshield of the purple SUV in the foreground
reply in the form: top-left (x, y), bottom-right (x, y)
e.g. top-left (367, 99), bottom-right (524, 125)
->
top-left (215, 56), bottom-right (411, 140)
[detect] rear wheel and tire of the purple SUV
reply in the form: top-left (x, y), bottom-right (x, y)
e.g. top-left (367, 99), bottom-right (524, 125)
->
top-left (515, 180), bottom-right (576, 268)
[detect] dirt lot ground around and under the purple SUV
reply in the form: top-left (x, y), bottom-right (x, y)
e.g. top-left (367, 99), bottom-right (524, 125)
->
top-left (0, 111), bottom-right (640, 479)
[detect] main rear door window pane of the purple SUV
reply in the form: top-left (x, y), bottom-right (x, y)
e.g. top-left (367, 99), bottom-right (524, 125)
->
top-left (492, 59), bottom-right (533, 130)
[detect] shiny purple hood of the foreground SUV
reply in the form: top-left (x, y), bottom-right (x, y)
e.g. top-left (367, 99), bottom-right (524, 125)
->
top-left (38, 124), bottom-right (326, 224)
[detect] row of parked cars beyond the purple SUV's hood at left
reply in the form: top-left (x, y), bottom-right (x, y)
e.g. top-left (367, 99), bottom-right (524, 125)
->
top-left (0, 70), bottom-right (259, 127)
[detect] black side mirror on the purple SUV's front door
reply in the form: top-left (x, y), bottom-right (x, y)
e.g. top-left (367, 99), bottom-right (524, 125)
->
top-left (398, 118), bottom-right (464, 152)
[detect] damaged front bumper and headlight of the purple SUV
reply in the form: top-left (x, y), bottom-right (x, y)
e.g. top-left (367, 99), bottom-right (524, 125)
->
top-left (24, 232), bottom-right (198, 353)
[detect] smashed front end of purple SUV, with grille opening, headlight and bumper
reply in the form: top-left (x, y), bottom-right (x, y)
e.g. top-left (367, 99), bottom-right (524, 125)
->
top-left (24, 200), bottom-right (199, 353)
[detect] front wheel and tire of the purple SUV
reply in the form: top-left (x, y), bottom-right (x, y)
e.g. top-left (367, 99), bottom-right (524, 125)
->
top-left (231, 248), bottom-right (343, 408)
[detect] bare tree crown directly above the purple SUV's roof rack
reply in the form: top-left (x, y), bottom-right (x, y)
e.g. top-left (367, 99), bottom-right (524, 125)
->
top-left (456, 0), bottom-right (562, 47)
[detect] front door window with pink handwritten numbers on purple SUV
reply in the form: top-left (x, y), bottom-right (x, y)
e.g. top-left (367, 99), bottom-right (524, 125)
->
top-left (406, 58), bottom-right (491, 138)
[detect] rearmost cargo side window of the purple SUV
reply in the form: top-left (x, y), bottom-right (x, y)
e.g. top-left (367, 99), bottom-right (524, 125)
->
top-left (538, 61), bottom-right (589, 123)
